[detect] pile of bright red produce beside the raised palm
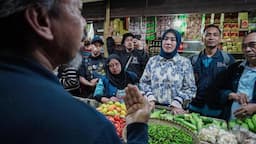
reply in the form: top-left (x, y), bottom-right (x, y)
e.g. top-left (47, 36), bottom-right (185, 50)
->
top-left (107, 116), bottom-right (125, 138)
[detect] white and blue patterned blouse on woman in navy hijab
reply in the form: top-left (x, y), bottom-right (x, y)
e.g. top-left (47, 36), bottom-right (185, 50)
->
top-left (140, 54), bottom-right (196, 108)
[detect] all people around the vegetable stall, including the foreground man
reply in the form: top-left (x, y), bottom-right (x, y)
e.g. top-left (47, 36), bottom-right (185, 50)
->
top-left (0, 0), bottom-right (256, 144)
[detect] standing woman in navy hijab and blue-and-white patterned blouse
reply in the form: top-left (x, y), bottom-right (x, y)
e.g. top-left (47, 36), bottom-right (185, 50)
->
top-left (140, 29), bottom-right (196, 114)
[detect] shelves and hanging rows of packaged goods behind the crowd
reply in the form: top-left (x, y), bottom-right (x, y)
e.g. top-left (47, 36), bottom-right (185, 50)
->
top-left (102, 12), bottom-right (256, 59)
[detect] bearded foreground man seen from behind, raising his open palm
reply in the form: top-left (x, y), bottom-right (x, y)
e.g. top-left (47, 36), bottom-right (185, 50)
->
top-left (0, 0), bottom-right (149, 144)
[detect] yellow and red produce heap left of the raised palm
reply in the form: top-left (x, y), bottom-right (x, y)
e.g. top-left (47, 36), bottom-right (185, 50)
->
top-left (97, 101), bottom-right (126, 138)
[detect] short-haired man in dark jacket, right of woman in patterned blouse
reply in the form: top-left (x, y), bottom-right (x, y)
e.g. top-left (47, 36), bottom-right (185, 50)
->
top-left (189, 24), bottom-right (235, 118)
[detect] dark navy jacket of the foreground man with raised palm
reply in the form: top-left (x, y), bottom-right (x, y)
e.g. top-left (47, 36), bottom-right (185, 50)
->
top-left (0, 57), bottom-right (148, 144)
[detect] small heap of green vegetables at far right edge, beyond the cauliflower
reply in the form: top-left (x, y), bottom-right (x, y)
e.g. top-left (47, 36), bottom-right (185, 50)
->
top-left (229, 114), bottom-right (256, 132)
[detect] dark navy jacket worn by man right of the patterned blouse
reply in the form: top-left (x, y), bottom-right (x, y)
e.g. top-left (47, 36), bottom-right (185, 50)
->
top-left (191, 50), bottom-right (235, 109)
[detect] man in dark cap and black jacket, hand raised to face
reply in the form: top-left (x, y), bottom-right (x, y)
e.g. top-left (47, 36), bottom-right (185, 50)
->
top-left (107, 33), bottom-right (149, 78)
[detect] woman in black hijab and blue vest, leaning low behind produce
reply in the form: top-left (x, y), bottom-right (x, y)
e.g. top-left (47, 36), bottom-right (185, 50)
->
top-left (94, 54), bottom-right (138, 103)
